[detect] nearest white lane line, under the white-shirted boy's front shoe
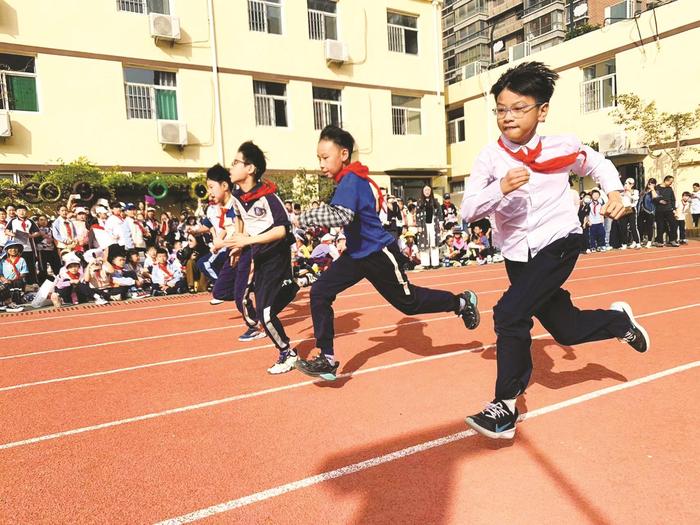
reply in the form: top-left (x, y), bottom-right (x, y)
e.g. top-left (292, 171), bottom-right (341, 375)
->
top-left (157, 361), bottom-right (700, 525)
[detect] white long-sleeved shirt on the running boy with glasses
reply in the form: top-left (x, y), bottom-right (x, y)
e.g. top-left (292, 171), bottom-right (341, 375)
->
top-left (462, 135), bottom-right (622, 262)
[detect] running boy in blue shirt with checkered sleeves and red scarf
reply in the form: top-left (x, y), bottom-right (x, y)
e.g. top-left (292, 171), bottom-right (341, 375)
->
top-left (296, 126), bottom-right (479, 381)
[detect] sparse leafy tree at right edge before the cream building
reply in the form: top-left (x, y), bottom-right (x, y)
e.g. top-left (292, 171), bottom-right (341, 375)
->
top-left (610, 93), bottom-right (700, 180)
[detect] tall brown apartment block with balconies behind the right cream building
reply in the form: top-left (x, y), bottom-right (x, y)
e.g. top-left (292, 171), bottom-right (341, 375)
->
top-left (442, 0), bottom-right (669, 84)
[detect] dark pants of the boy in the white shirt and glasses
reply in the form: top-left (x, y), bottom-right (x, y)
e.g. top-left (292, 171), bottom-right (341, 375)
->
top-left (493, 234), bottom-right (630, 399)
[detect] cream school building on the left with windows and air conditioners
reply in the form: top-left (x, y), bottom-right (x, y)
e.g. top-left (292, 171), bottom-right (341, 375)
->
top-left (0, 0), bottom-right (447, 201)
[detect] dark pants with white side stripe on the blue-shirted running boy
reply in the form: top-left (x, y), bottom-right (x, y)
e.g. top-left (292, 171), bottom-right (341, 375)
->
top-left (311, 243), bottom-right (459, 355)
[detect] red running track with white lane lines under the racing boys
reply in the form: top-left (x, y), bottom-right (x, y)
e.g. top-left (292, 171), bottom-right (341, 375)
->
top-left (0, 247), bottom-right (700, 524)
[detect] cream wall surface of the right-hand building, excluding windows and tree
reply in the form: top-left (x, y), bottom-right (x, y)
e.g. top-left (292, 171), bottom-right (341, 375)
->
top-left (447, 0), bottom-right (700, 202)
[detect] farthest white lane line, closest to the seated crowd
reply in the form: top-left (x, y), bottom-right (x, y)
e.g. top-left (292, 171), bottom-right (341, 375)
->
top-left (0, 252), bottom-right (700, 326)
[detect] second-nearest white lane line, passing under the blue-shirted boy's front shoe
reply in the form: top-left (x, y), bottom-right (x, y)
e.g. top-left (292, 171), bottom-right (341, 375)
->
top-left (0, 303), bottom-right (700, 450)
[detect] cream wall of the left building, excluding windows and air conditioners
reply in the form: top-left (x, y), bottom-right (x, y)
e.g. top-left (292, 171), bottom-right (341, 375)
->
top-left (0, 0), bottom-right (447, 199)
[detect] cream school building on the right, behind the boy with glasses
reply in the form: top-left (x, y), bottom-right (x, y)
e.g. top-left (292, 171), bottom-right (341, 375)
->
top-left (446, 0), bottom-right (700, 202)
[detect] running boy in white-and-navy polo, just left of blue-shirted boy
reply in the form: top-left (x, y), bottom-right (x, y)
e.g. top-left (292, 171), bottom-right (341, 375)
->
top-left (224, 141), bottom-right (299, 374)
